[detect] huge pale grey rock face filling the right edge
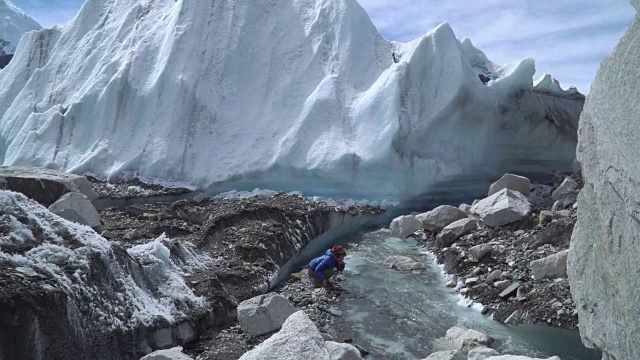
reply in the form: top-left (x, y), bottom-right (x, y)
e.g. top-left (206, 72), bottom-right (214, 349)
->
top-left (568, 7), bottom-right (640, 360)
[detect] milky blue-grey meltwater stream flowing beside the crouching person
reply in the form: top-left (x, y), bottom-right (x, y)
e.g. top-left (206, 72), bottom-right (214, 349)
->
top-left (338, 230), bottom-right (601, 360)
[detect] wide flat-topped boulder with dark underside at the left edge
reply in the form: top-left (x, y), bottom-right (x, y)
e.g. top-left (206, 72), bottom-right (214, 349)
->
top-left (0, 166), bottom-right (100, 210)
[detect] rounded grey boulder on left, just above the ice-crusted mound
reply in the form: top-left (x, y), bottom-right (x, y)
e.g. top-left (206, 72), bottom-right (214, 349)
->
top-left (49, 192), bottom-right (102, 232)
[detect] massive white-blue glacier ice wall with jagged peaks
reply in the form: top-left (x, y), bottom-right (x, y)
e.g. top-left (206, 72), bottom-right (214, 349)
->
top-left (0, 0), bottom-right (584, 201)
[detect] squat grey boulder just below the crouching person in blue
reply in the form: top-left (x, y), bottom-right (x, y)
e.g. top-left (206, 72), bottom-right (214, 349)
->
top-left (238, 294), bottom-right (296, 336)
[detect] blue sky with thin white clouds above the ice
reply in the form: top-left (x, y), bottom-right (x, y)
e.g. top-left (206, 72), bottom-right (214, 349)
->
top-left (12, 0), bottom-right (635, 93)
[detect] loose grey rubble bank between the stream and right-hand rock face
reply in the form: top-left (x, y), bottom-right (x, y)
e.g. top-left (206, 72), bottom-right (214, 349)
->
top-left (420, 174), bottom-right (582, 329)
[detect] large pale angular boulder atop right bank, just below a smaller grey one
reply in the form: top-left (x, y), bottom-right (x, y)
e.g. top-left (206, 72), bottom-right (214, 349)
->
top-left (471, 189), bottom-right (531, 227)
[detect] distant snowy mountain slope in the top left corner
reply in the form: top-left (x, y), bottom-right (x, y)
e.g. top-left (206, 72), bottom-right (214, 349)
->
top-left (0, 0), bottom-right (42, 54)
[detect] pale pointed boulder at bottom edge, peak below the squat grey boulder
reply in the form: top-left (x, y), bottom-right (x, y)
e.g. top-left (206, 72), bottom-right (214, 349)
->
top-left (240, 311), bottom-right (332, 360)
